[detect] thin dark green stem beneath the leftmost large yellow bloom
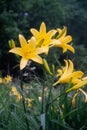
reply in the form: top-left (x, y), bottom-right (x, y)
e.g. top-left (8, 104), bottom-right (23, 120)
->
top-left (20, 71), bottom-right (29, 130)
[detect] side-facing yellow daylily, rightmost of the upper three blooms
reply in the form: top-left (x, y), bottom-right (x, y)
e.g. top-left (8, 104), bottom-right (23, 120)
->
top-left (53, 27), bottom-right (75, 53)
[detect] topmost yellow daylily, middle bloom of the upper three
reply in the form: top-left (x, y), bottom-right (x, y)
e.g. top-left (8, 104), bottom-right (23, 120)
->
top-left (30, 22), bottom-right (57, 53)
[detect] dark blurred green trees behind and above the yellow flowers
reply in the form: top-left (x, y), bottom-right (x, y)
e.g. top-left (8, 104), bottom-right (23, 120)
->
top-left (0, 0), bottom-right (87, 75)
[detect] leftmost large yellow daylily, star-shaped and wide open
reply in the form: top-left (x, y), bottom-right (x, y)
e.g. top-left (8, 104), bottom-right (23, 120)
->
top-left (9, 35), bottom-right (46, 70)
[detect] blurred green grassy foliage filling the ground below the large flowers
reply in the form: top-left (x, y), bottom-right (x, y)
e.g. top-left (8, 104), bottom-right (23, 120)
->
top-left (0, 72), bottom-right (87, 130)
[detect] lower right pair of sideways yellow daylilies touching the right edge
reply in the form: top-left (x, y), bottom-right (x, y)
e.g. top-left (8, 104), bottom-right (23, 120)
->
top-left (54, 60), bottom-right (87, 92)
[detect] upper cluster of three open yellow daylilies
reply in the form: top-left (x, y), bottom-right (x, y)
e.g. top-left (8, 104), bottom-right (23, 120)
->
top-left (9, 22), bottom-right (74, 70)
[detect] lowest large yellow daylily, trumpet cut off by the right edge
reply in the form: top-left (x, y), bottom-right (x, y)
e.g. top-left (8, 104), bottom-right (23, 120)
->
top-left (66, 77), bottom-right (87, 93)
